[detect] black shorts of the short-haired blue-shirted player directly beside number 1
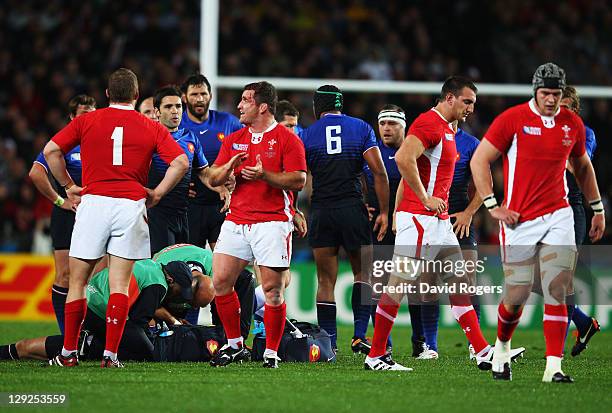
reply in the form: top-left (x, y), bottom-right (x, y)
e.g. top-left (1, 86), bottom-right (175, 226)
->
top-left (147, 208), bottom-right (189, 254)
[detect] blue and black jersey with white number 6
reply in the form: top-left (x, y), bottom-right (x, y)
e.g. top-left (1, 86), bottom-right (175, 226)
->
top-left (300, 114), bottom-right (376, 208)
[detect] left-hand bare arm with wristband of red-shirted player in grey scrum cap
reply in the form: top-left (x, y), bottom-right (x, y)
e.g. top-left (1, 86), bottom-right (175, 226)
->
top-left (470, 138), bottom-right (520, 225)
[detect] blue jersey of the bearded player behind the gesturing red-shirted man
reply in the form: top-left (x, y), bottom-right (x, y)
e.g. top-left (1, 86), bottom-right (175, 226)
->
top-left (179, 109), bottom-right (242, 205)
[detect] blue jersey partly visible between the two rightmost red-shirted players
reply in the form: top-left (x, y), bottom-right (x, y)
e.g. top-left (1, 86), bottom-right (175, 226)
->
top-left (448, 128), bottom-right (480, 214)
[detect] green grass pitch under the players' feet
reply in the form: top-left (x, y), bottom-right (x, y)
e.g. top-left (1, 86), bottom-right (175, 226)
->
top-left (0, 322), bottom-right (612, 413)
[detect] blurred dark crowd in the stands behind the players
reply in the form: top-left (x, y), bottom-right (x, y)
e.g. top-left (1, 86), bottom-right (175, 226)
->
top-left (0, 0), bottom-right (612, 251)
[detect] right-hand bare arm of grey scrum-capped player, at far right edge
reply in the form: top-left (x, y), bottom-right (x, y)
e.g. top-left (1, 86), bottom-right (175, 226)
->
top-left (569, 152), bottom-right (606, 242)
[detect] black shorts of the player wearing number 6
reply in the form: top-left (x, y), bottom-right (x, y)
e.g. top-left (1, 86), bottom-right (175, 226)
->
top-left (308, 204), bottom-right (372, 251)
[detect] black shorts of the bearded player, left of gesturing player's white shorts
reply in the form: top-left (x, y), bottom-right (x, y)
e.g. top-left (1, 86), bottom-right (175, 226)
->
top-left (188, 203), bottom-right (225, 248)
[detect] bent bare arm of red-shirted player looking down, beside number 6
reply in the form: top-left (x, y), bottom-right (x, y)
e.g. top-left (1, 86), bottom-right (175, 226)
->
top-left (395, 135), bottom-right (448, 214)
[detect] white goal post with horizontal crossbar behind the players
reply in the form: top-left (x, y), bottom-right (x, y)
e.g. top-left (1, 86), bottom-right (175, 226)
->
top-left (200, 0), bottom-right (612, 108)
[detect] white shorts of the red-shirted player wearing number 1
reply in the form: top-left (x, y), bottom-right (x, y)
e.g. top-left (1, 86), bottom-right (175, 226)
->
top-left (70, 194), bottom-right (151, 260)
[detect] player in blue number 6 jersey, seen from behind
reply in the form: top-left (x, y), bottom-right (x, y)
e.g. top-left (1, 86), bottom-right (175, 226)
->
top-left (301, 85), bottom-right (389, 353)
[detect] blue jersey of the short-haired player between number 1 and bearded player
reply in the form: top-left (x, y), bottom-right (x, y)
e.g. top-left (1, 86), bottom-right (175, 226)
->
top-left (149, 129), bottom-right (208, 212)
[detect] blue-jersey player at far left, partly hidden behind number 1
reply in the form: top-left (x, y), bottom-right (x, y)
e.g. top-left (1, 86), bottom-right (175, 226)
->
top-left (30, 95), bottom-right (96, 334)
